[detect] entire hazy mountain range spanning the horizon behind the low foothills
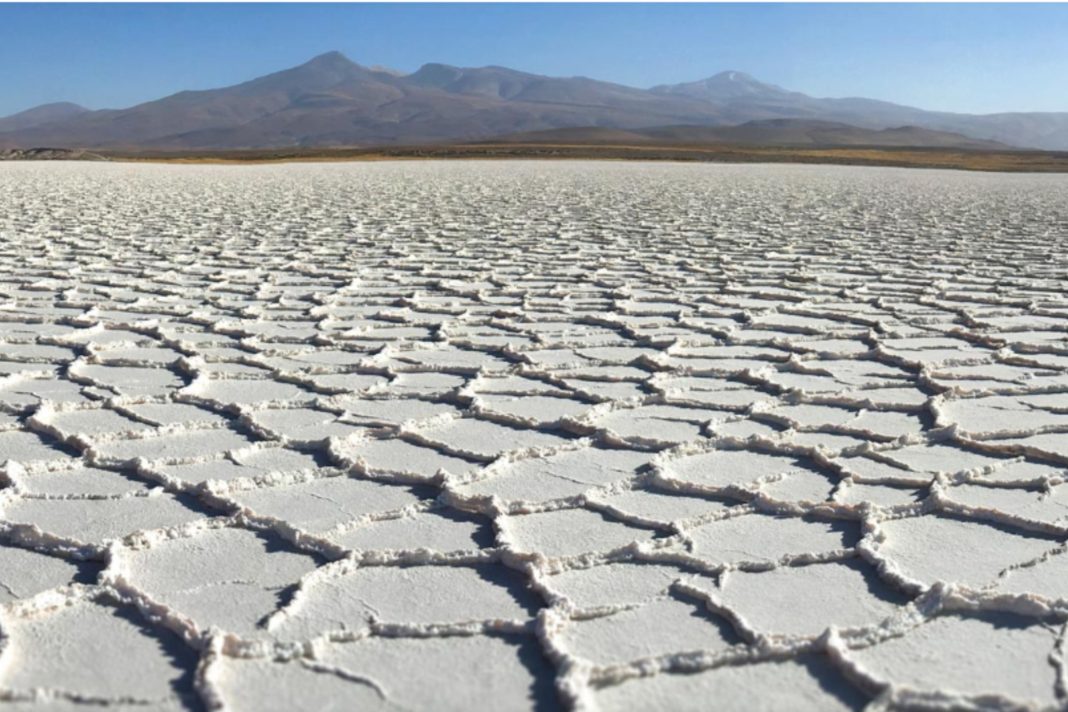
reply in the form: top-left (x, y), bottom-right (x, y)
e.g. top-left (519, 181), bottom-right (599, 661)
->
top-left (0, 52), bottom-right (1068, 151)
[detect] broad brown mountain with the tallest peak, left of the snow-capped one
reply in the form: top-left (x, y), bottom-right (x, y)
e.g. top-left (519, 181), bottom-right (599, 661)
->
top-left (0, 52), bottom-right (717, 149)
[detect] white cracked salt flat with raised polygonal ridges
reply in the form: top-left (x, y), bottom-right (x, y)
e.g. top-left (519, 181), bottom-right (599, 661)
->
top-left (0, 161), bottom-right (1068, 710)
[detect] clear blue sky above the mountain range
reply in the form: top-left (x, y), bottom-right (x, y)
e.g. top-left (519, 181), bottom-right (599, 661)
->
top-left (0, 3), bottom-right (1068, 115)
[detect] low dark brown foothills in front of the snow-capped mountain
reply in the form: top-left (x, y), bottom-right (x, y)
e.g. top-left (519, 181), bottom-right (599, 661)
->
top-left (483, 118), bottom-right (1010, 151)
